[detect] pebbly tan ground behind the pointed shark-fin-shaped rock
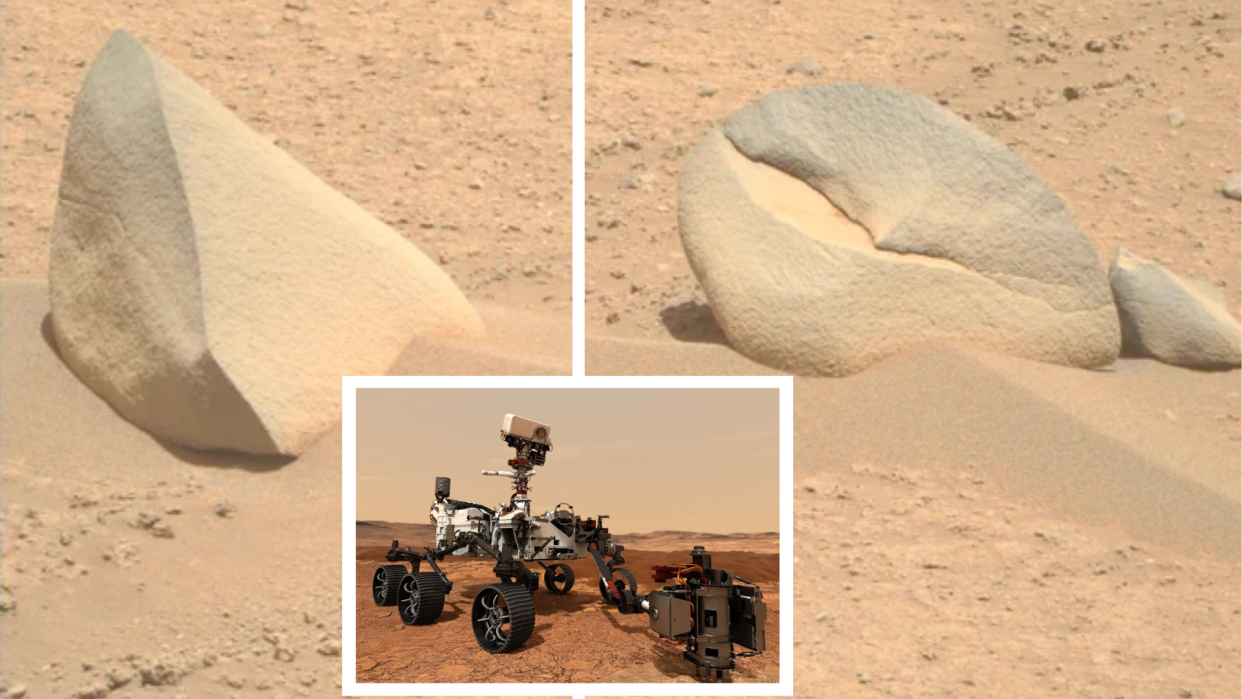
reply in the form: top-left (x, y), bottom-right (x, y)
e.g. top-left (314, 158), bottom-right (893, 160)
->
top-left (0, 0), bottom-right (573, 374)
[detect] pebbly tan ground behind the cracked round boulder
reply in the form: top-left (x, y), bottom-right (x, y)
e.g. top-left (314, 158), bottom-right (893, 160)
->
top-left (586, 0), bottom-right (1242, 340)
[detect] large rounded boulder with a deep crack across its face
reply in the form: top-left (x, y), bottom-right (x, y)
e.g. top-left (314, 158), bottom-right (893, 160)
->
top-left (679, 84), bottom-right (1120, 375)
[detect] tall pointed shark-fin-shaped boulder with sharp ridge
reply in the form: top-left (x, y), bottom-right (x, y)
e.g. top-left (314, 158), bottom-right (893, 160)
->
top-left (48, 32), bottom-right (482, 454)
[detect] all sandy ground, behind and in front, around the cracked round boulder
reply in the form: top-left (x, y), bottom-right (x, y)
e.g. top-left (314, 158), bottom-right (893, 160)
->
top-left (586, 0), bottom-right (1242, 699)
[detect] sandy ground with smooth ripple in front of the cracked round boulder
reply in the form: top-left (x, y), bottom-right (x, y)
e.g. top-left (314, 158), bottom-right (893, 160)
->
top-left (600, 341), bottom-right (1242, 699)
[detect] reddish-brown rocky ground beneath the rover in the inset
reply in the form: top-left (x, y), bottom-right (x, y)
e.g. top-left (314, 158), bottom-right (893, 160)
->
top-left (355, 538), bottom-right (781, 683)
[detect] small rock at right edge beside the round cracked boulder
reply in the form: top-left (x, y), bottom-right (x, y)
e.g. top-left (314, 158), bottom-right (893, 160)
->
top-left (1109, 247), bottom-right (1242, 369)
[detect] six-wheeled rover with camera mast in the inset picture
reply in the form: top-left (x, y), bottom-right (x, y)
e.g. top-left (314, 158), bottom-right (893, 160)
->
top-left (371, 415), bottom-right (768, 682)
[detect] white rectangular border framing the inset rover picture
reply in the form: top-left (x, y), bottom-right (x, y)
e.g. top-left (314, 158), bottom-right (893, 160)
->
top-left (340, 376), bottom-right (794, 697)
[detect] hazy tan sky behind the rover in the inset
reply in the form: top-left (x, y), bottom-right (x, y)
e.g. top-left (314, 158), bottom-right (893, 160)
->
top-left (358, 389), bottom-right (780, 534)
